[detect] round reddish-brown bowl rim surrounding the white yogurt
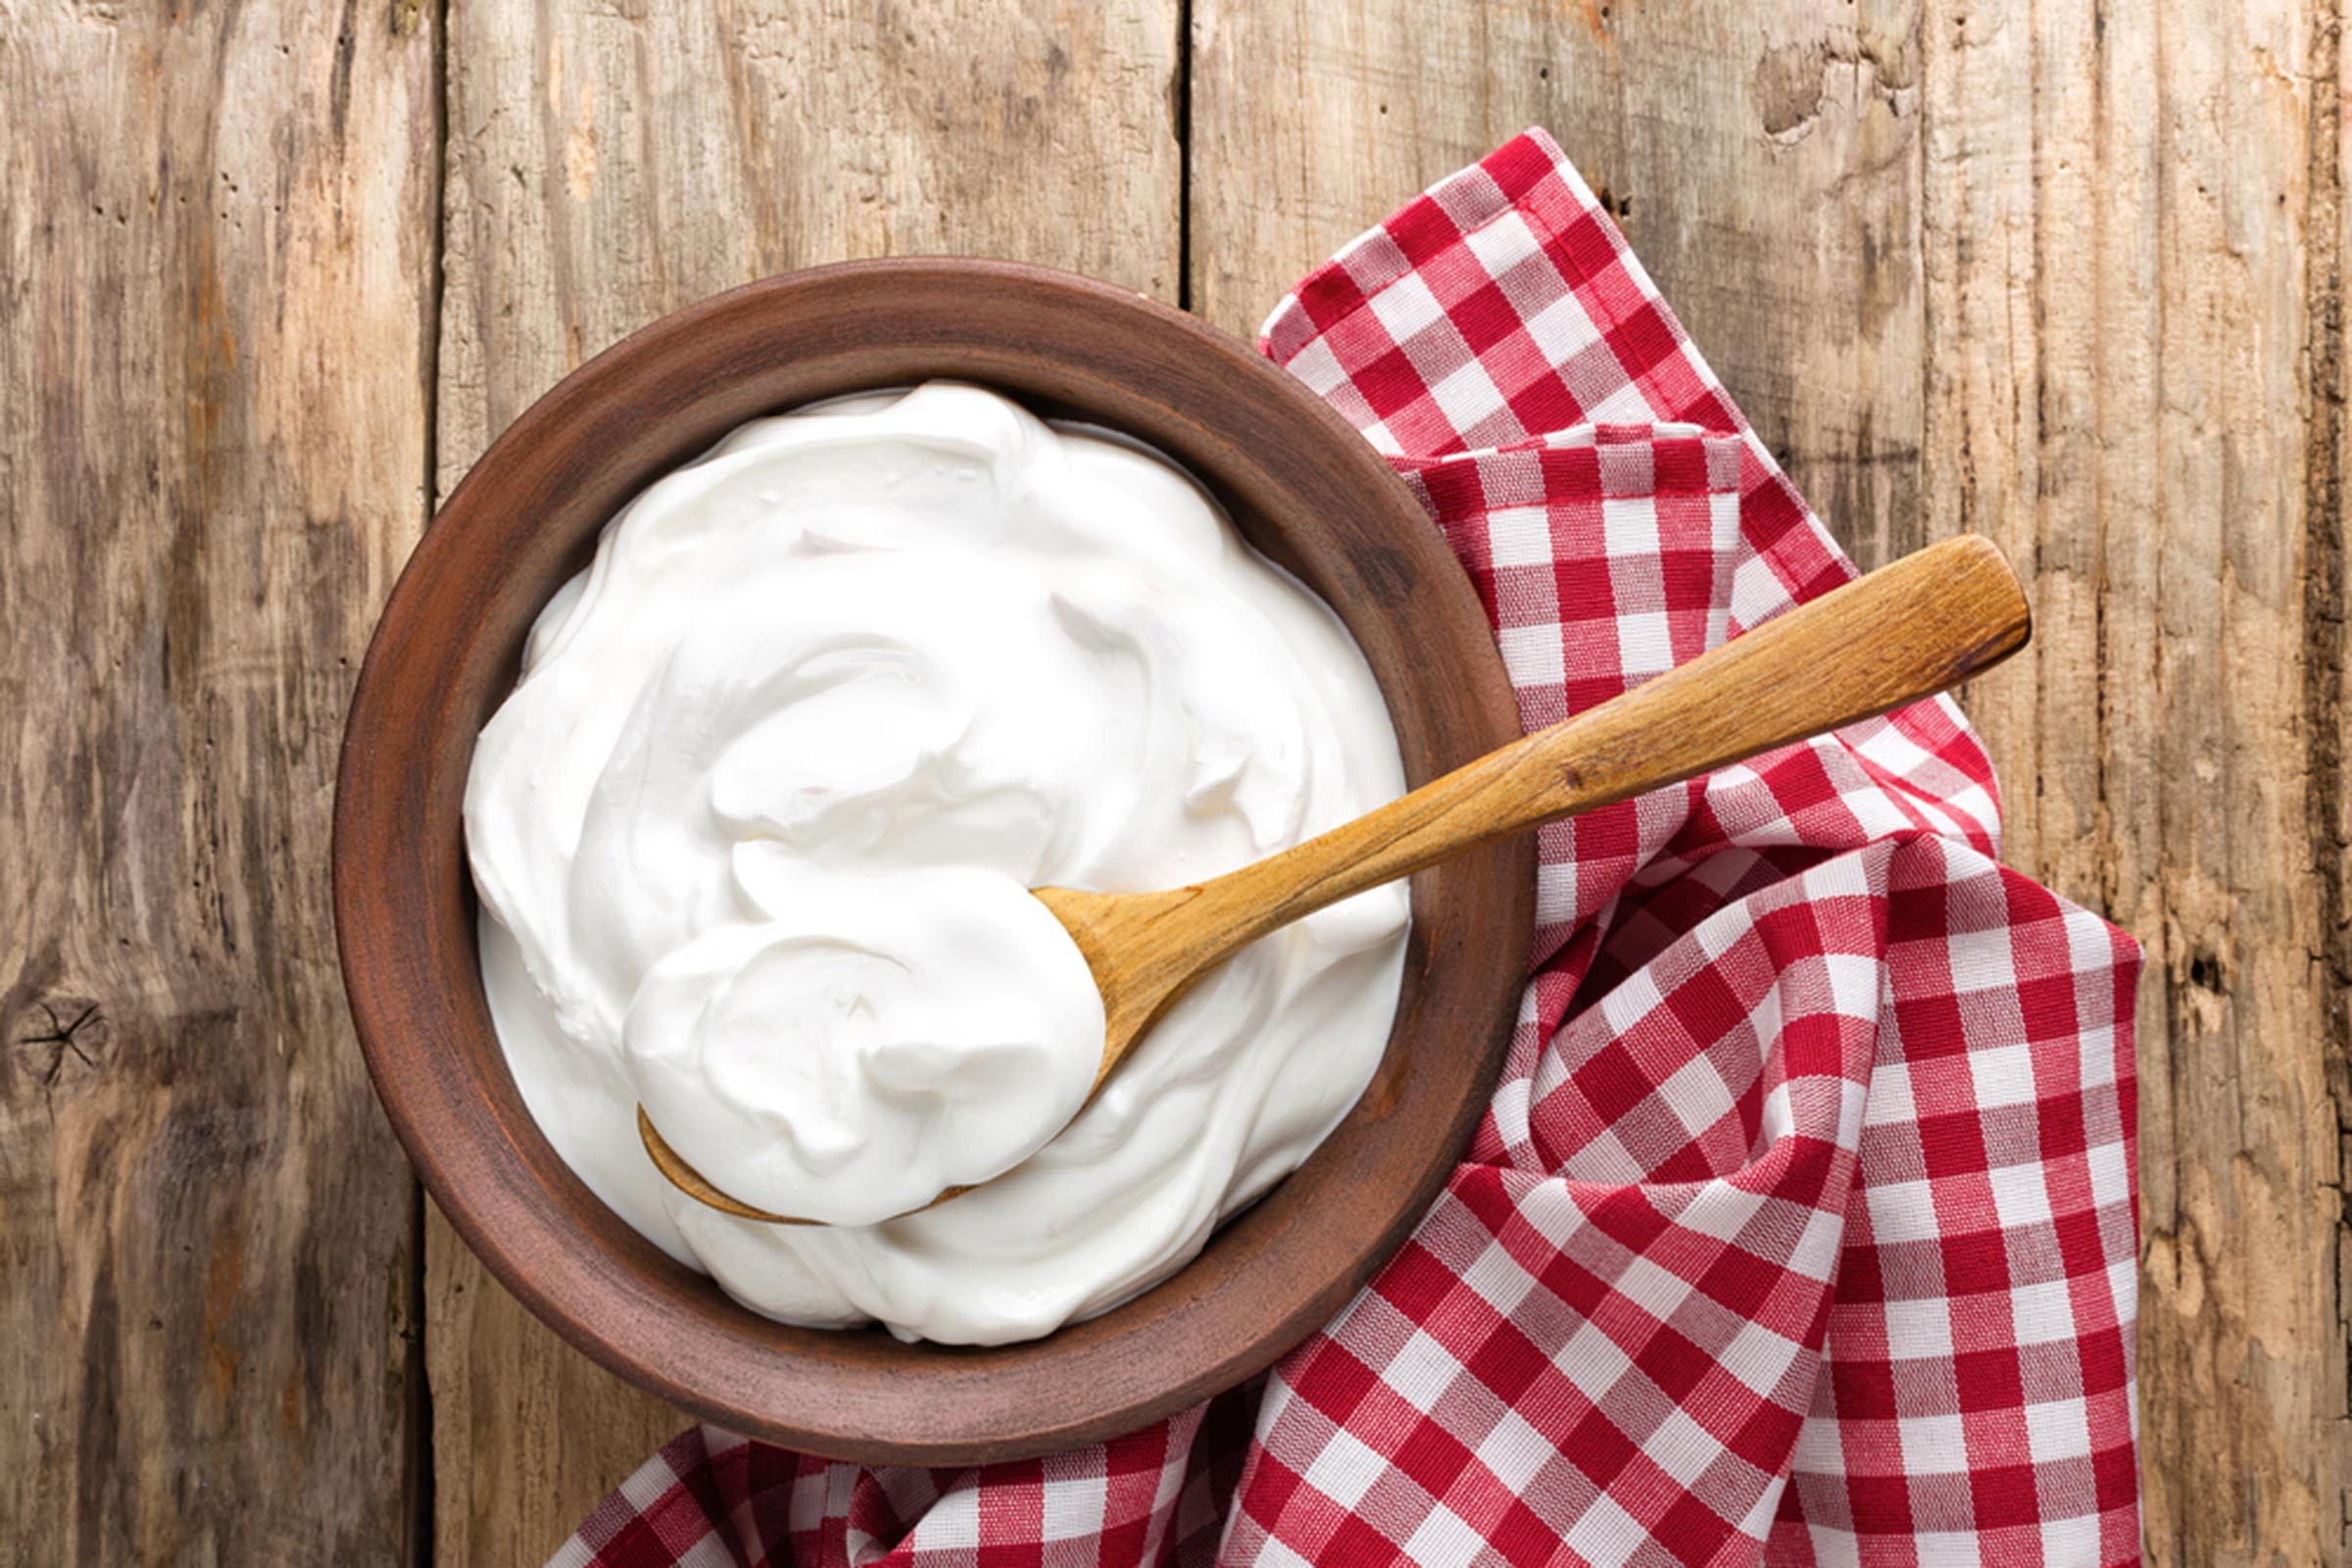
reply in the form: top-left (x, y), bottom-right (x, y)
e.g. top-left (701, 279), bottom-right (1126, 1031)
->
top-left (334, 259), bottom-right (1534, 1464)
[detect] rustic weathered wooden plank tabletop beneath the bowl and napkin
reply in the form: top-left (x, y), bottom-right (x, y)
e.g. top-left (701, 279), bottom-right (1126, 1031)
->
top-left (0, 0), bottom-right (2352, 1566)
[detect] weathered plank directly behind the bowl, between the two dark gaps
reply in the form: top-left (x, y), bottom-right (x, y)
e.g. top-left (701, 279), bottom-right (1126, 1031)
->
top-left (428, 0), bottom-right (1178, 1563)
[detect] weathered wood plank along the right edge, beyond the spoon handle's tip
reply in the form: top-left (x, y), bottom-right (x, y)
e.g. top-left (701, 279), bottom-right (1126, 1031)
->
top-left (1922, 0), bottom-right (2352, 1563)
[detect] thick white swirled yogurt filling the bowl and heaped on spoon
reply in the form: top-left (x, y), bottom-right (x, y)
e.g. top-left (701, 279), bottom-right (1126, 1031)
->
top-left (466, 383), bottom-right (1406, 1345)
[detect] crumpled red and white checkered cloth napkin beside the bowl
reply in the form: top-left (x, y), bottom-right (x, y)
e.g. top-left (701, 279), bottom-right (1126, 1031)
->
top-left (555, 131), bottom-right (2140, 1568)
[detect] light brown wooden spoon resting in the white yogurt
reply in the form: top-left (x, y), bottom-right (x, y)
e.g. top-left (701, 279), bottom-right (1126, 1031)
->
top-left (637, 534), bottom-right (2033, 1225)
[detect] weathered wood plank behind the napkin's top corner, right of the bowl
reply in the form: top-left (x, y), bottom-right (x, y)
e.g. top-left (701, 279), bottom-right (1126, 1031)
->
top-left (1190, 0), bottom-right (1924, 566)
